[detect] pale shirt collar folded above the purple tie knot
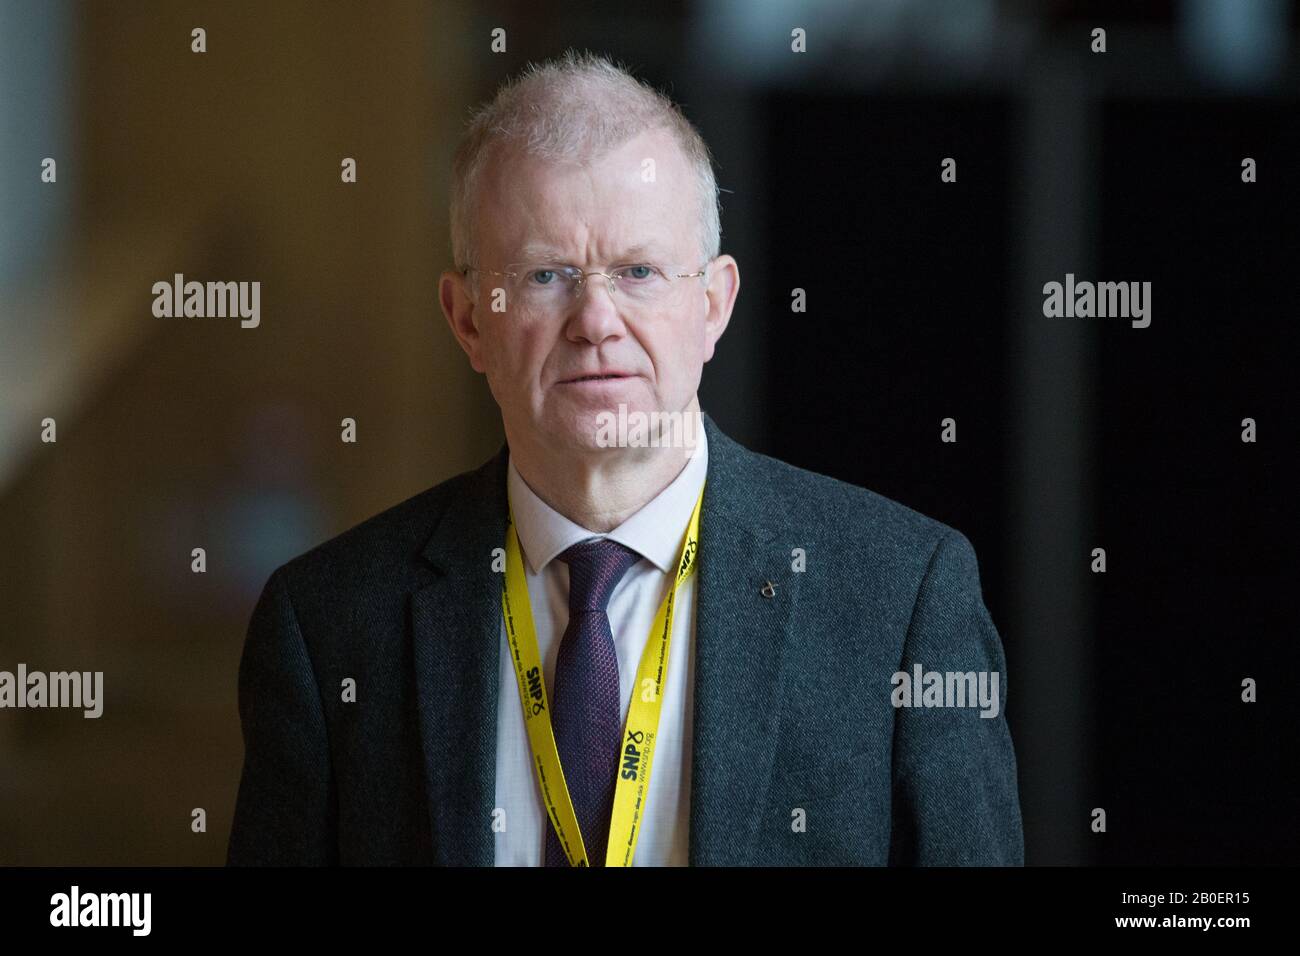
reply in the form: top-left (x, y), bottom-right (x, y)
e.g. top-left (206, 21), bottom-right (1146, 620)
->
top-left (507, 428), bottom-right (709, 575)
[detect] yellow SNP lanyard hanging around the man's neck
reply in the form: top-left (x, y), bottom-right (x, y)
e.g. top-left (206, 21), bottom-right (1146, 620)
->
top-left (501, 488), bottom-right (705, 866)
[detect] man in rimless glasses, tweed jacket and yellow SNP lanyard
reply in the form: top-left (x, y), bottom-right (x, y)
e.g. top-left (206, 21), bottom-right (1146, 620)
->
top-left (229, 53), bottom-right (1023, 866)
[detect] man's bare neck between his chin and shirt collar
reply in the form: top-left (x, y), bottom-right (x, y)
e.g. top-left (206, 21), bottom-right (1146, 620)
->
top-left (510, 399), bottom-right (703, 535)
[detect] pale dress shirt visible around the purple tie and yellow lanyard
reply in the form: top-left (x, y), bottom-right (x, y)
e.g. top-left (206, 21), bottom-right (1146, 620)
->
top-left (495, 429), bottom-right (709, 866)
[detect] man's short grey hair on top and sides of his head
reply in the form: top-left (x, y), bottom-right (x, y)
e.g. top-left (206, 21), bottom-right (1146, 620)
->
top-left (451, 49), bottom-right (722, 269)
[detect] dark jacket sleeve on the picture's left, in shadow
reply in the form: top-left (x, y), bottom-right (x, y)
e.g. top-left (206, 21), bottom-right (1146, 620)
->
top-left (226, 568), bottom-right (338, 866)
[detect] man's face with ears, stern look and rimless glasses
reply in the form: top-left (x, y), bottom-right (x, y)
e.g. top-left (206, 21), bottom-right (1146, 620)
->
top-left (442, 130), bottom-right (738, 450)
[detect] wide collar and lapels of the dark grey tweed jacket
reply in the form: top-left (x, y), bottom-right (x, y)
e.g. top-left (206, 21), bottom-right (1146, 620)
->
top-left (411, 414), bottom-right (798, 866)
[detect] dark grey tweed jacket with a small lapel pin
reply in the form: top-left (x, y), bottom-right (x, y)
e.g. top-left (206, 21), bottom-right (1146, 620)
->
top-left (228, 415), bottom-right (1024, 866)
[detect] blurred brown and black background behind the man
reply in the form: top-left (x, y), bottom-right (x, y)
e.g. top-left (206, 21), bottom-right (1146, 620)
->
top-left (0, 0), bottom-right (1300, 865)
